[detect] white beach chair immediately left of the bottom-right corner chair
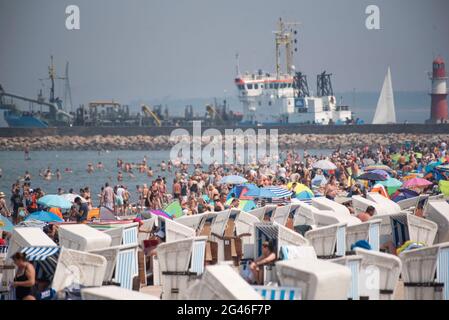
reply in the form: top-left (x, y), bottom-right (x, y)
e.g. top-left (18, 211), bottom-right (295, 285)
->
top-left (355, 248), bottom-right (402, 300)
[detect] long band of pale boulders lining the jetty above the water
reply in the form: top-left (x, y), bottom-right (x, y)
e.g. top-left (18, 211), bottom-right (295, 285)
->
top-left (0, 133), bottom-right (449, 151)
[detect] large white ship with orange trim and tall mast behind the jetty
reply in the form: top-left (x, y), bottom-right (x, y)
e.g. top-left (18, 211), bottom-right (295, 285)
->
top-left (235, 19), bottom-right (352, 124)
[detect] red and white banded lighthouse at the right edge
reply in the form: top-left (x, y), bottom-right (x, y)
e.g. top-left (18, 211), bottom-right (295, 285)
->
top-left (429, 57), bottom-right (449, 123)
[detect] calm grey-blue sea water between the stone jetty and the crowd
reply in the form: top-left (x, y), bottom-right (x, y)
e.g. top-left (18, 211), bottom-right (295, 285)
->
top-left (0, 150), bottom-right (331, 206)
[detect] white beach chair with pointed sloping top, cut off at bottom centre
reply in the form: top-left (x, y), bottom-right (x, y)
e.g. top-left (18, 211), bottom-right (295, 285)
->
top-left (184, 265), bottom-right (262, 300)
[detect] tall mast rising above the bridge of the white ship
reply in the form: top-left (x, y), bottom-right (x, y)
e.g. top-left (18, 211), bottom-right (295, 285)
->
top-left (274, 18), bottom-right (300, 79)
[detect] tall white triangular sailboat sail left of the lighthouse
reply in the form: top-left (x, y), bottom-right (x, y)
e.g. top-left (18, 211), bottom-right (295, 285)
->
top-left (373, 67), bottom-right (396, 124)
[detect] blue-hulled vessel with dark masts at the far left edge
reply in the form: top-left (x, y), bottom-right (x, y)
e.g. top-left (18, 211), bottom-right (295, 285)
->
top-left (0, 56), bottom-right (73, 128)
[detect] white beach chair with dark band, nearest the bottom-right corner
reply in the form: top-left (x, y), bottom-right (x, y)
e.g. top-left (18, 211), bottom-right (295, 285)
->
top-left (399, 246), bottom-right (444, 300)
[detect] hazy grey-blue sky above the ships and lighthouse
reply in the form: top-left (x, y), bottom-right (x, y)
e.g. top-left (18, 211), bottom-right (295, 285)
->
top-left (0, 0), bottom-right (449, 105)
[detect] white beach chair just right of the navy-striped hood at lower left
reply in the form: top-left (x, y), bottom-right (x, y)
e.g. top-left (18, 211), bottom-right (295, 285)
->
top-left (51, 247), bottom-right (107, 292)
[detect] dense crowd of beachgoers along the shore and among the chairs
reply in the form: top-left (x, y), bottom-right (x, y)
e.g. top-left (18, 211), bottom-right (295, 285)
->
top-left (0, 141), bottom-right (449, 299)
